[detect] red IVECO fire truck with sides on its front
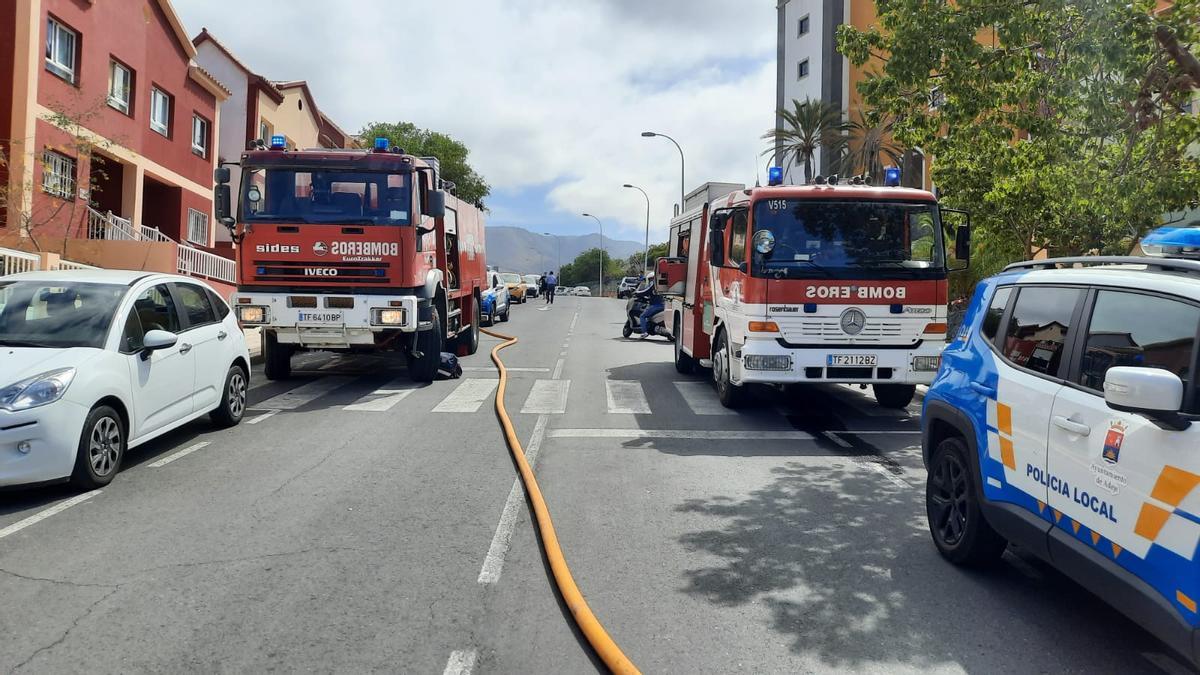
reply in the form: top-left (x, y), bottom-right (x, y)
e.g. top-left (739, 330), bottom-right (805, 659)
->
top-left (216, 136), bottom-right (486, 382)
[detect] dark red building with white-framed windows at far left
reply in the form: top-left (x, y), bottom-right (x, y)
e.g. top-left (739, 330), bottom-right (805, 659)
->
top-left (0, 0), bottom-right (233, 282)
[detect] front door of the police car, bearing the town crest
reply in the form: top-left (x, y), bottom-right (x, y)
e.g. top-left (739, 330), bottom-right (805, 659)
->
top-left (1048, 289), bottom-right (1200, 626)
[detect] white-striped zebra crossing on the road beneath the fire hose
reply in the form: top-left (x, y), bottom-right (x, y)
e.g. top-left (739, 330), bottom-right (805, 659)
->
top-left (248, 369), bottom-right (908, 423)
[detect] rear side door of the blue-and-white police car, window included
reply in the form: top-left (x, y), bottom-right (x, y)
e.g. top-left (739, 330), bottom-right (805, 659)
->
top-left (972, 286), bottom-right (1084, 520)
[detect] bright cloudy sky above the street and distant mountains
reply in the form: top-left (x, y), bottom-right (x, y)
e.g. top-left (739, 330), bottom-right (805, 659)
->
top-left (174, 0), bottom-right (775, 241)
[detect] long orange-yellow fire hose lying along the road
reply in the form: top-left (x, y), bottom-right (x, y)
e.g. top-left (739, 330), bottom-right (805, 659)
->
top-left (480, 329), bottom-right (641, 674)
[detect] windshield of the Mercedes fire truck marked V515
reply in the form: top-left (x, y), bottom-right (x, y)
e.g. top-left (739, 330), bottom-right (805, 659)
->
top-left (751, 199), bottom-right (946, 279)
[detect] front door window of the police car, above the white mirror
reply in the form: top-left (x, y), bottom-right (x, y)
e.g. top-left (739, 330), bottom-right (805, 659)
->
top-left (1079, 291), bottom-right (1200, 406)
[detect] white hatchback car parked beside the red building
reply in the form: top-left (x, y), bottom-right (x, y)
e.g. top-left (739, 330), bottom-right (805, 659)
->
top-left (0, 270), bottom-right (250, 489)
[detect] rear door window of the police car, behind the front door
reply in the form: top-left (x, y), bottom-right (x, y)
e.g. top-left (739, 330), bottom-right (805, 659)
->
top-left (1003, 286), bottom-right (1082, 376)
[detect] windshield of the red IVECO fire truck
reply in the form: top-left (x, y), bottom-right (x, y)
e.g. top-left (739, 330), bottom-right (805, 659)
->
top-left (241, 167), bottom-right (413, 225)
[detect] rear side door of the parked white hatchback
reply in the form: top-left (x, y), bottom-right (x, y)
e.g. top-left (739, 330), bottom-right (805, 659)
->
top-left (172, 282), bottom-right (233, 412)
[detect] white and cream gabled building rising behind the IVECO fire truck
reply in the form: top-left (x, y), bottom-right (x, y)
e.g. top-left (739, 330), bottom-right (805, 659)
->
top-left (192, 28), bottom-right (354, 246)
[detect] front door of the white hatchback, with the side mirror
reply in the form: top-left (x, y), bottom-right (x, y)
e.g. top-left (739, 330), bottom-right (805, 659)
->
top-left (121, 283), bottom-right (196, 438)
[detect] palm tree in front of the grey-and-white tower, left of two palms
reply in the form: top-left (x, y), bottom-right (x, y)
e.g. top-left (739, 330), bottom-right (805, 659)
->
top-left (762, 98), bottom-right (847, 183)
